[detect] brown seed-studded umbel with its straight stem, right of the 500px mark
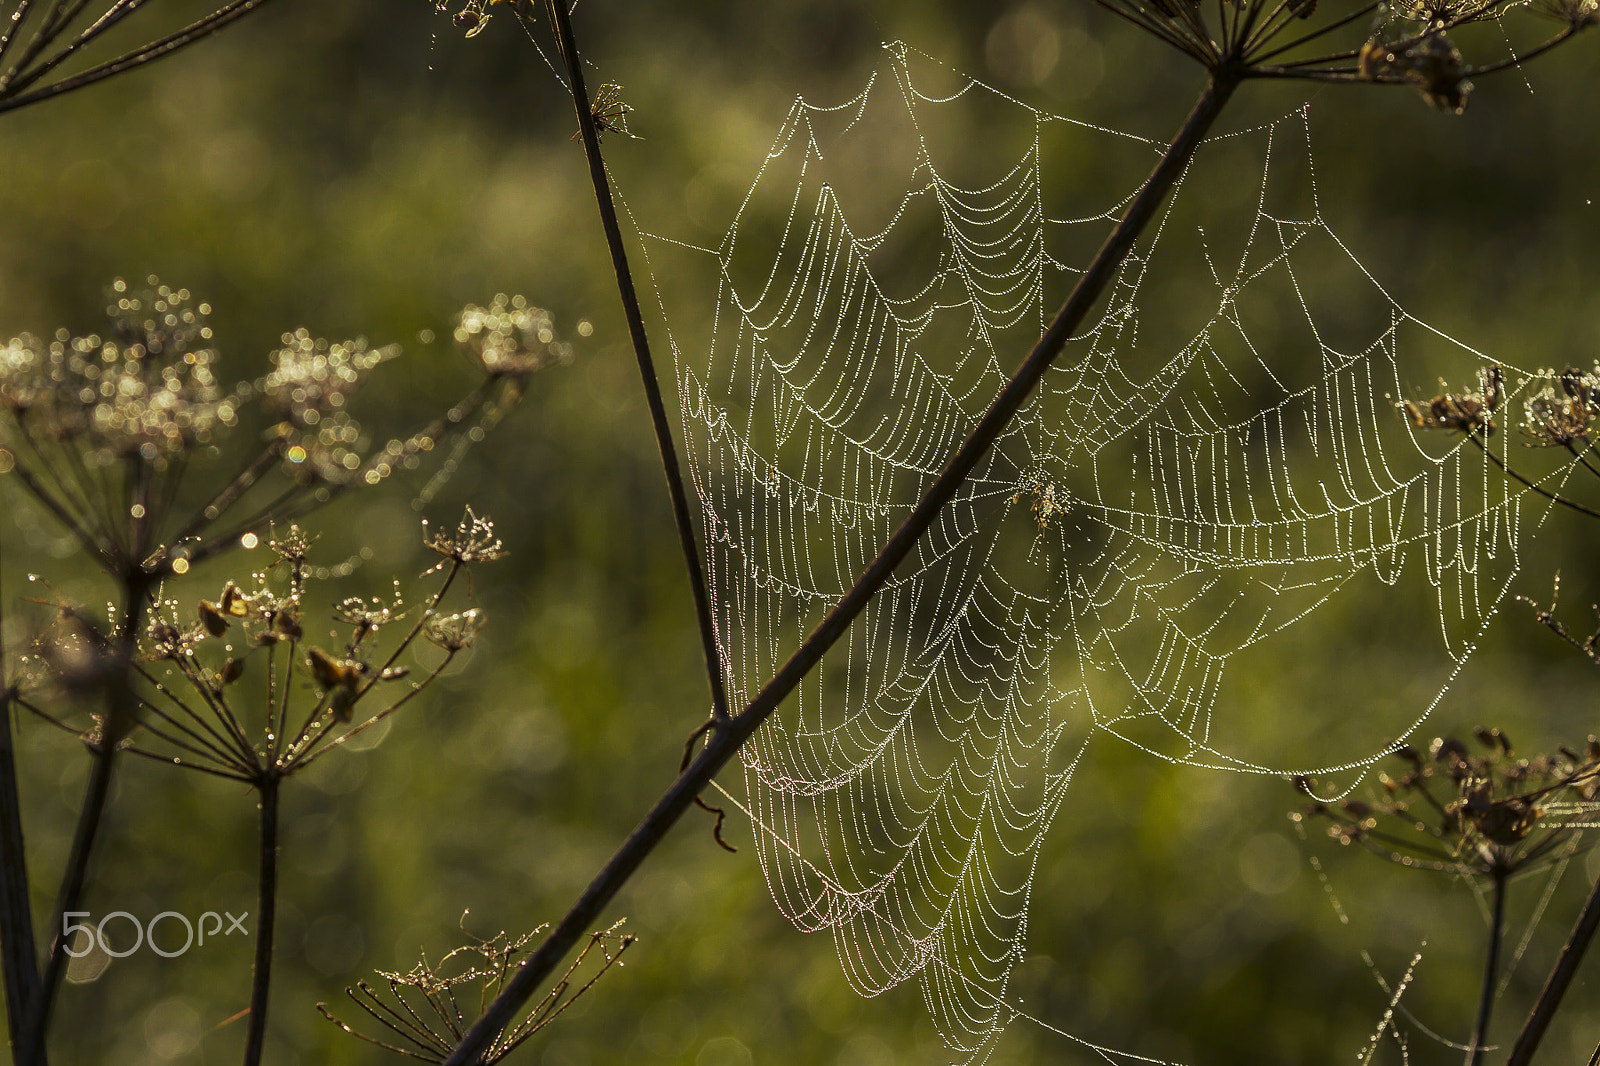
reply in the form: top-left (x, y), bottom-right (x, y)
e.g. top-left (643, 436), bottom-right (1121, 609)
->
top-left (14, 512), bottom-right (504, 1063)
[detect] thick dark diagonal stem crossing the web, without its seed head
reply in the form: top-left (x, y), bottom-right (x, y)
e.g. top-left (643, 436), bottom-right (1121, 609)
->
top-left (445, 67), bottom-right (1242, 1066)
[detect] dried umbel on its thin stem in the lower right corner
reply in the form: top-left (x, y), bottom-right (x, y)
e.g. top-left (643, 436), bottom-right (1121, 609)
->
top-left (1291, 728), bottom-right (1600, 1063)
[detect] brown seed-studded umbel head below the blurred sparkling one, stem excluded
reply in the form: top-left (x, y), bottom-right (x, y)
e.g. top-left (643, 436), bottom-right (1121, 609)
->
top-left (16, 525), bottom-right (483, 783)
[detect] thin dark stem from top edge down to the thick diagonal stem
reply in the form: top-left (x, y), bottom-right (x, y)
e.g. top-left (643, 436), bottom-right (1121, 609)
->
top-left (546, 0), bottom-right (730, 723)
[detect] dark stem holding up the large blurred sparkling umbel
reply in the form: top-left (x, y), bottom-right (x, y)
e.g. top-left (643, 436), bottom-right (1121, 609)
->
top-left (18, 563), bottom-right (149, 1066)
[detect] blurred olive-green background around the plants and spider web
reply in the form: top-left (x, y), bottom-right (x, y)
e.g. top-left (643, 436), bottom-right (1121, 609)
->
top-left (0, 0), bottom-right (1600, 1066)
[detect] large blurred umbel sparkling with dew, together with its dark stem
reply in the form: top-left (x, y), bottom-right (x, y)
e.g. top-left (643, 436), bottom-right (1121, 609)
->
top-left (0, 277), bottom-right (563, 1061)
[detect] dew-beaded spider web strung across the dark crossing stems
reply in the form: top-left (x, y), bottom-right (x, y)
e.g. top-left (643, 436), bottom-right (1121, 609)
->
top-left (627, 45), bottom-right (1574, 1061)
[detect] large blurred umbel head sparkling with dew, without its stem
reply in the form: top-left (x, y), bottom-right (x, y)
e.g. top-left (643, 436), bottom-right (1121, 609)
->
top-left (0, 277), bottom-right (571, 581)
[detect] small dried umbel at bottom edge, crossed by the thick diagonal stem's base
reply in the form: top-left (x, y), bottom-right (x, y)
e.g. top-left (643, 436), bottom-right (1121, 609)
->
top-left (317, 919), bottom-right (638, 1064)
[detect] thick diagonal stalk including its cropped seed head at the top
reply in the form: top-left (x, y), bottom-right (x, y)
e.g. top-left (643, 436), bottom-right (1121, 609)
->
top-left (450, 0), bottom-right (1597, 1066)
